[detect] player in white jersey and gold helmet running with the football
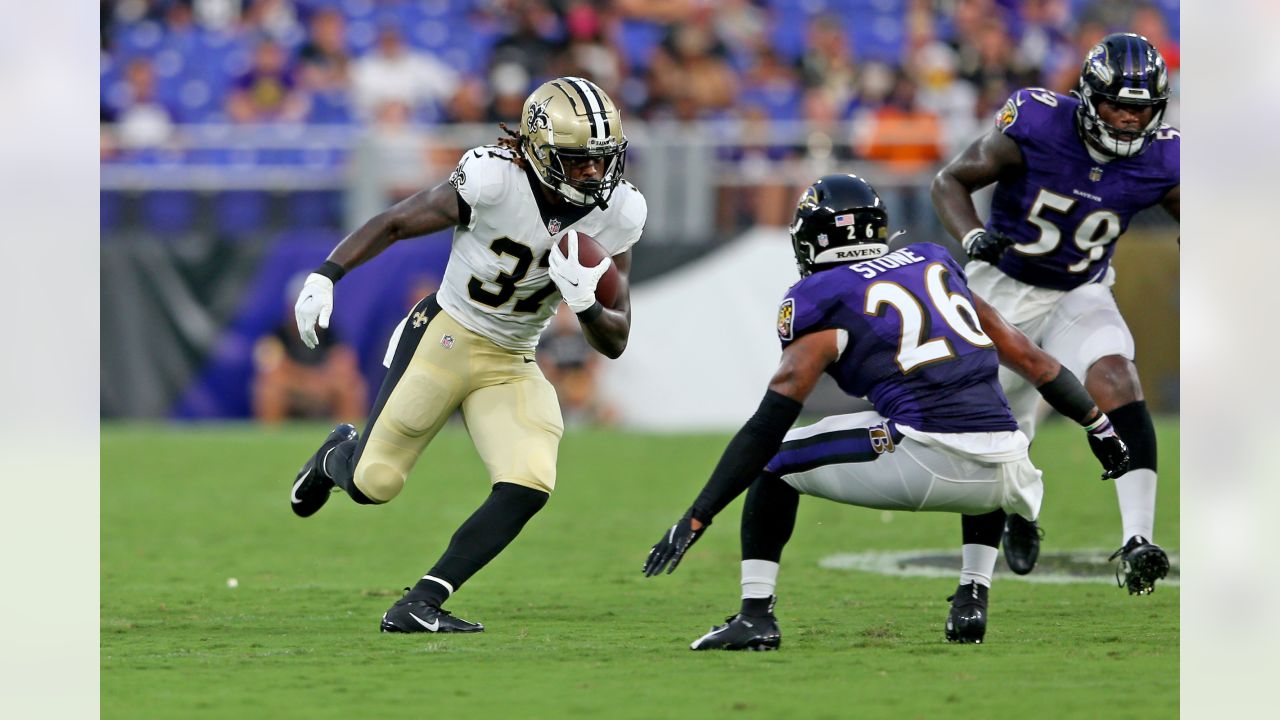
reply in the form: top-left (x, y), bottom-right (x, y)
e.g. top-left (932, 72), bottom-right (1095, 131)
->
top-left (291, 77), bottom-right (646, 633)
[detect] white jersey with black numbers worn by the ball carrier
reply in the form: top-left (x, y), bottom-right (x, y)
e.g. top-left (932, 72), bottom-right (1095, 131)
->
top-left (436, 145), bottom-right (648, 351)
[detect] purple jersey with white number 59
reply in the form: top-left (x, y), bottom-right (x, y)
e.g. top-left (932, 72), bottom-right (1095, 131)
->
top-left (987, 87), bottom-right (1181, 290)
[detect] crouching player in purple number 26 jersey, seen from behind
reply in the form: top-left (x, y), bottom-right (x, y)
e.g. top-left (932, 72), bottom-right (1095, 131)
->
top-left (644, 174), bottom-right (1128, 650)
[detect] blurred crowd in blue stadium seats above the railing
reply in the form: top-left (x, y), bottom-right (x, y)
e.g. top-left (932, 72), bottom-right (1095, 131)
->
top-left (101, 0), bottom-right (1179, 149)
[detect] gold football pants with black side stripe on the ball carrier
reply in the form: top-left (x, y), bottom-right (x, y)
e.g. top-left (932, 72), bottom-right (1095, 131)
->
top-left (355, 295), bottom-right (564, 502)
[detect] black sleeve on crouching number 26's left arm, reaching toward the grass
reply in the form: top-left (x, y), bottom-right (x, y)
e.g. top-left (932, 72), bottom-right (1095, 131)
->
top-left (689, 389), bottom-right (804, 523)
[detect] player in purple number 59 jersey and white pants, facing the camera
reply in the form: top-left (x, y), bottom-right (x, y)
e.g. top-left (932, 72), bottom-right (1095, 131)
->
top-left (932, 33), bottom-right (1180, 594)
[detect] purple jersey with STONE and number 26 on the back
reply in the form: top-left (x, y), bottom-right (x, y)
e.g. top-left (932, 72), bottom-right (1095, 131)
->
top-left (778, 242), bottom-right (1018, 433)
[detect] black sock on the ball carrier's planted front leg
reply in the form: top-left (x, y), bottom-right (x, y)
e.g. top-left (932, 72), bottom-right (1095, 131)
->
top-left (406, 483), bottom-right (549, 605)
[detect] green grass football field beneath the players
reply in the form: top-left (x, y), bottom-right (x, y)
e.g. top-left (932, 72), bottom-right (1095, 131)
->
top-left (101, 421), bottom-right (1179, 719)
